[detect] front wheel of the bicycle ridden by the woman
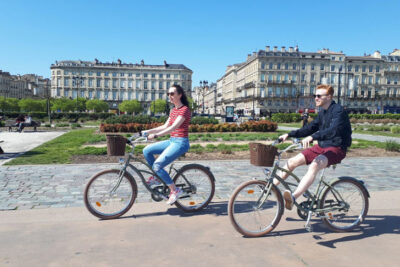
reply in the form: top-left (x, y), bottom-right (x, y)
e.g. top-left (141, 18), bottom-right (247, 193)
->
top-left (84, 170), bottom-right (137, 219)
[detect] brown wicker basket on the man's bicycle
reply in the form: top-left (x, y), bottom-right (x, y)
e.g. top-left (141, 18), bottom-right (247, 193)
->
top-left (249, 143), bottom-right (278, 167)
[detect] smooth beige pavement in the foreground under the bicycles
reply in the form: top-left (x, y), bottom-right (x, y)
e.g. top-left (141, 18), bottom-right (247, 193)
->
top-left (0, 191), bottom-right (400, 267)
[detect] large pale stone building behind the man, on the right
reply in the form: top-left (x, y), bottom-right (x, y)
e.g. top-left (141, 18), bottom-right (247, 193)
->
top-left (216, 46), bottom-right (400, 116)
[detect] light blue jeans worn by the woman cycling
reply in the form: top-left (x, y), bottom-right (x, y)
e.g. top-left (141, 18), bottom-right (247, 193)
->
top-left (143, 137), bottom-right (190, 185)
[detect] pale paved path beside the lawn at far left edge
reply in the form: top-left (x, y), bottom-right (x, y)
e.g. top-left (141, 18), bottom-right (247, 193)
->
top-left (0, 130), bottom-right (66, 165)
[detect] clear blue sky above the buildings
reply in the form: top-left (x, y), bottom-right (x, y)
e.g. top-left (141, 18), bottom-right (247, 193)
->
top-left (0, 0), bottom-right (400, 86)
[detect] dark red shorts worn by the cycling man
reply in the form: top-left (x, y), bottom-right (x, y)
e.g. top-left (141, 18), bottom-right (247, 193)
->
top-left (301, 145), bottom-right (346, 166)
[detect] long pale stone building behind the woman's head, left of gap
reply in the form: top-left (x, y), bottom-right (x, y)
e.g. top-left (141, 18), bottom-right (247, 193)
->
top-left (50, 59), bottom-right (193, 113)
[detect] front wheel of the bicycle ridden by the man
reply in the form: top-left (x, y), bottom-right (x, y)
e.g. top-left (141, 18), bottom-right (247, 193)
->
top-left (228, 180), bottom-right (283, 237)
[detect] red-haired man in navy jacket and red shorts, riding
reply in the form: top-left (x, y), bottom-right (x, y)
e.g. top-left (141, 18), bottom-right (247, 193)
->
top-left (274, 84), bottom-right (352, 210)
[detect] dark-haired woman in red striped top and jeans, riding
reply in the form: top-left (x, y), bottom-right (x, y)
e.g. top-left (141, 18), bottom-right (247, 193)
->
top-left (142, 85), bottom-right (191, 204)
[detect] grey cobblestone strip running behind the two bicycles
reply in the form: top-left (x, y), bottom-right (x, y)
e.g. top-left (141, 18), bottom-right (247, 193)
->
top-left (0, 157), bottom-right (400, 210)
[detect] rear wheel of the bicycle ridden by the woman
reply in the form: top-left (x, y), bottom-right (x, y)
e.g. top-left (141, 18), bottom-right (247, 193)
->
top-left (173, 164), bottom-right (215, 212)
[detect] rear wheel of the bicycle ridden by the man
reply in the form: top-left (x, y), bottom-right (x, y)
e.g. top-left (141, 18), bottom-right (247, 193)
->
top-left (319, 177), bottom-right (369, 232)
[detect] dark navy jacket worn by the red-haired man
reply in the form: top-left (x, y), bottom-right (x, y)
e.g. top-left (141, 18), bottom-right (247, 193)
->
top-left (289, 101), bottom-right (351, 150)
